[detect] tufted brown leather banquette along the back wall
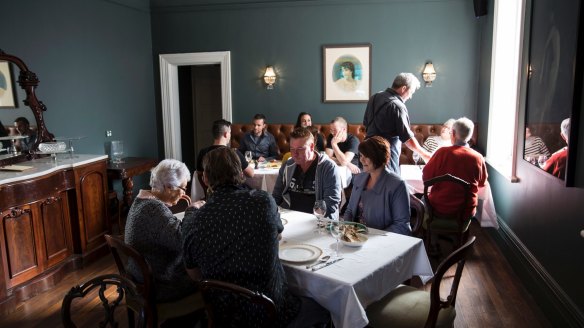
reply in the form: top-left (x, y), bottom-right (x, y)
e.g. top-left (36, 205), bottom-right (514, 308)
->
top-left (231, 123), bottom-right (478, 164)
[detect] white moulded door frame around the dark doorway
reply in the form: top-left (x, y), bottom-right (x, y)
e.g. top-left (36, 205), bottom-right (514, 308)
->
top-left (160, 51), bottom-right (231, 161)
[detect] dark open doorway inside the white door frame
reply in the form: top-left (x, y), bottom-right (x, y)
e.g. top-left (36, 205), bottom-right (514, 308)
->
top-left (178, 64), bottom-right (222, 172)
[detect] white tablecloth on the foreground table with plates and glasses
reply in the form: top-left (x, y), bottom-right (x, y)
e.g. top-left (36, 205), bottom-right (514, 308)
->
top-left (281, 211), bottom-right (433, 328)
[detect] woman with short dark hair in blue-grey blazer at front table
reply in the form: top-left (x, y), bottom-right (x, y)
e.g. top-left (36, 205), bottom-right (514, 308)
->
top-left (344, 136), bottom-right (412, 235)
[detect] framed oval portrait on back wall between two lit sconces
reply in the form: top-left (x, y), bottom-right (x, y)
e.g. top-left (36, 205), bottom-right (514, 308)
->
top-left (322, 43), bottom-right (371, 103)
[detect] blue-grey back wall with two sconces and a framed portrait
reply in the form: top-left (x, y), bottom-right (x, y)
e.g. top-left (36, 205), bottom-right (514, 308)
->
top-left (152, 0), bottom-right (480, 123)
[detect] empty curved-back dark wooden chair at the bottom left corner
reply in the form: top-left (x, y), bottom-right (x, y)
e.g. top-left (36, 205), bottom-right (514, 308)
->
top-left (61, 274), bottom-right (151, 328)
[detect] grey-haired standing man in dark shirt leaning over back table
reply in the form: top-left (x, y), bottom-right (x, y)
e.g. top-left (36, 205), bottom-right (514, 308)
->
top-left (363, 73), bottom-right (432, 175)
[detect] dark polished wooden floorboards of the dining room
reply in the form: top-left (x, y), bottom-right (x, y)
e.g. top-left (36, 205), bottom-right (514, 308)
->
top-left (0, 223), bottom-right (552, 328)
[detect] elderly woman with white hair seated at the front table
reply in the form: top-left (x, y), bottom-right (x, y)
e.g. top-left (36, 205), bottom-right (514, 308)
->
top-left (125, 159), bottom-right (204, 302)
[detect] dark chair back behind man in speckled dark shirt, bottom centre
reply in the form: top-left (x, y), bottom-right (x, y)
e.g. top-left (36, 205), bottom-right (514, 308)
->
top-left (200, 280), bottom-right (277, 328)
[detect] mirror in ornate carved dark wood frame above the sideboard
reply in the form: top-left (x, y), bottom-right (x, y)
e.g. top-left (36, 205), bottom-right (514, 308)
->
top-left (0, 49), bottom-right (54, 166)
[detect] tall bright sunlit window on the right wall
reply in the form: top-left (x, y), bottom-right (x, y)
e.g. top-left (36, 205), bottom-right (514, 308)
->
top-left (487, 0), bottom-right (524, 181)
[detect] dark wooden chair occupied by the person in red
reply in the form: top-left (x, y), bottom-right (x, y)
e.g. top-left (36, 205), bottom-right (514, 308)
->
top-left (423, 174), bottom-right (472, 249)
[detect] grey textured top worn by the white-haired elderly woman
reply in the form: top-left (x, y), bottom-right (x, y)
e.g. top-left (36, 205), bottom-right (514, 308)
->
top-left (124, 198), bottom-right (197, 301)
